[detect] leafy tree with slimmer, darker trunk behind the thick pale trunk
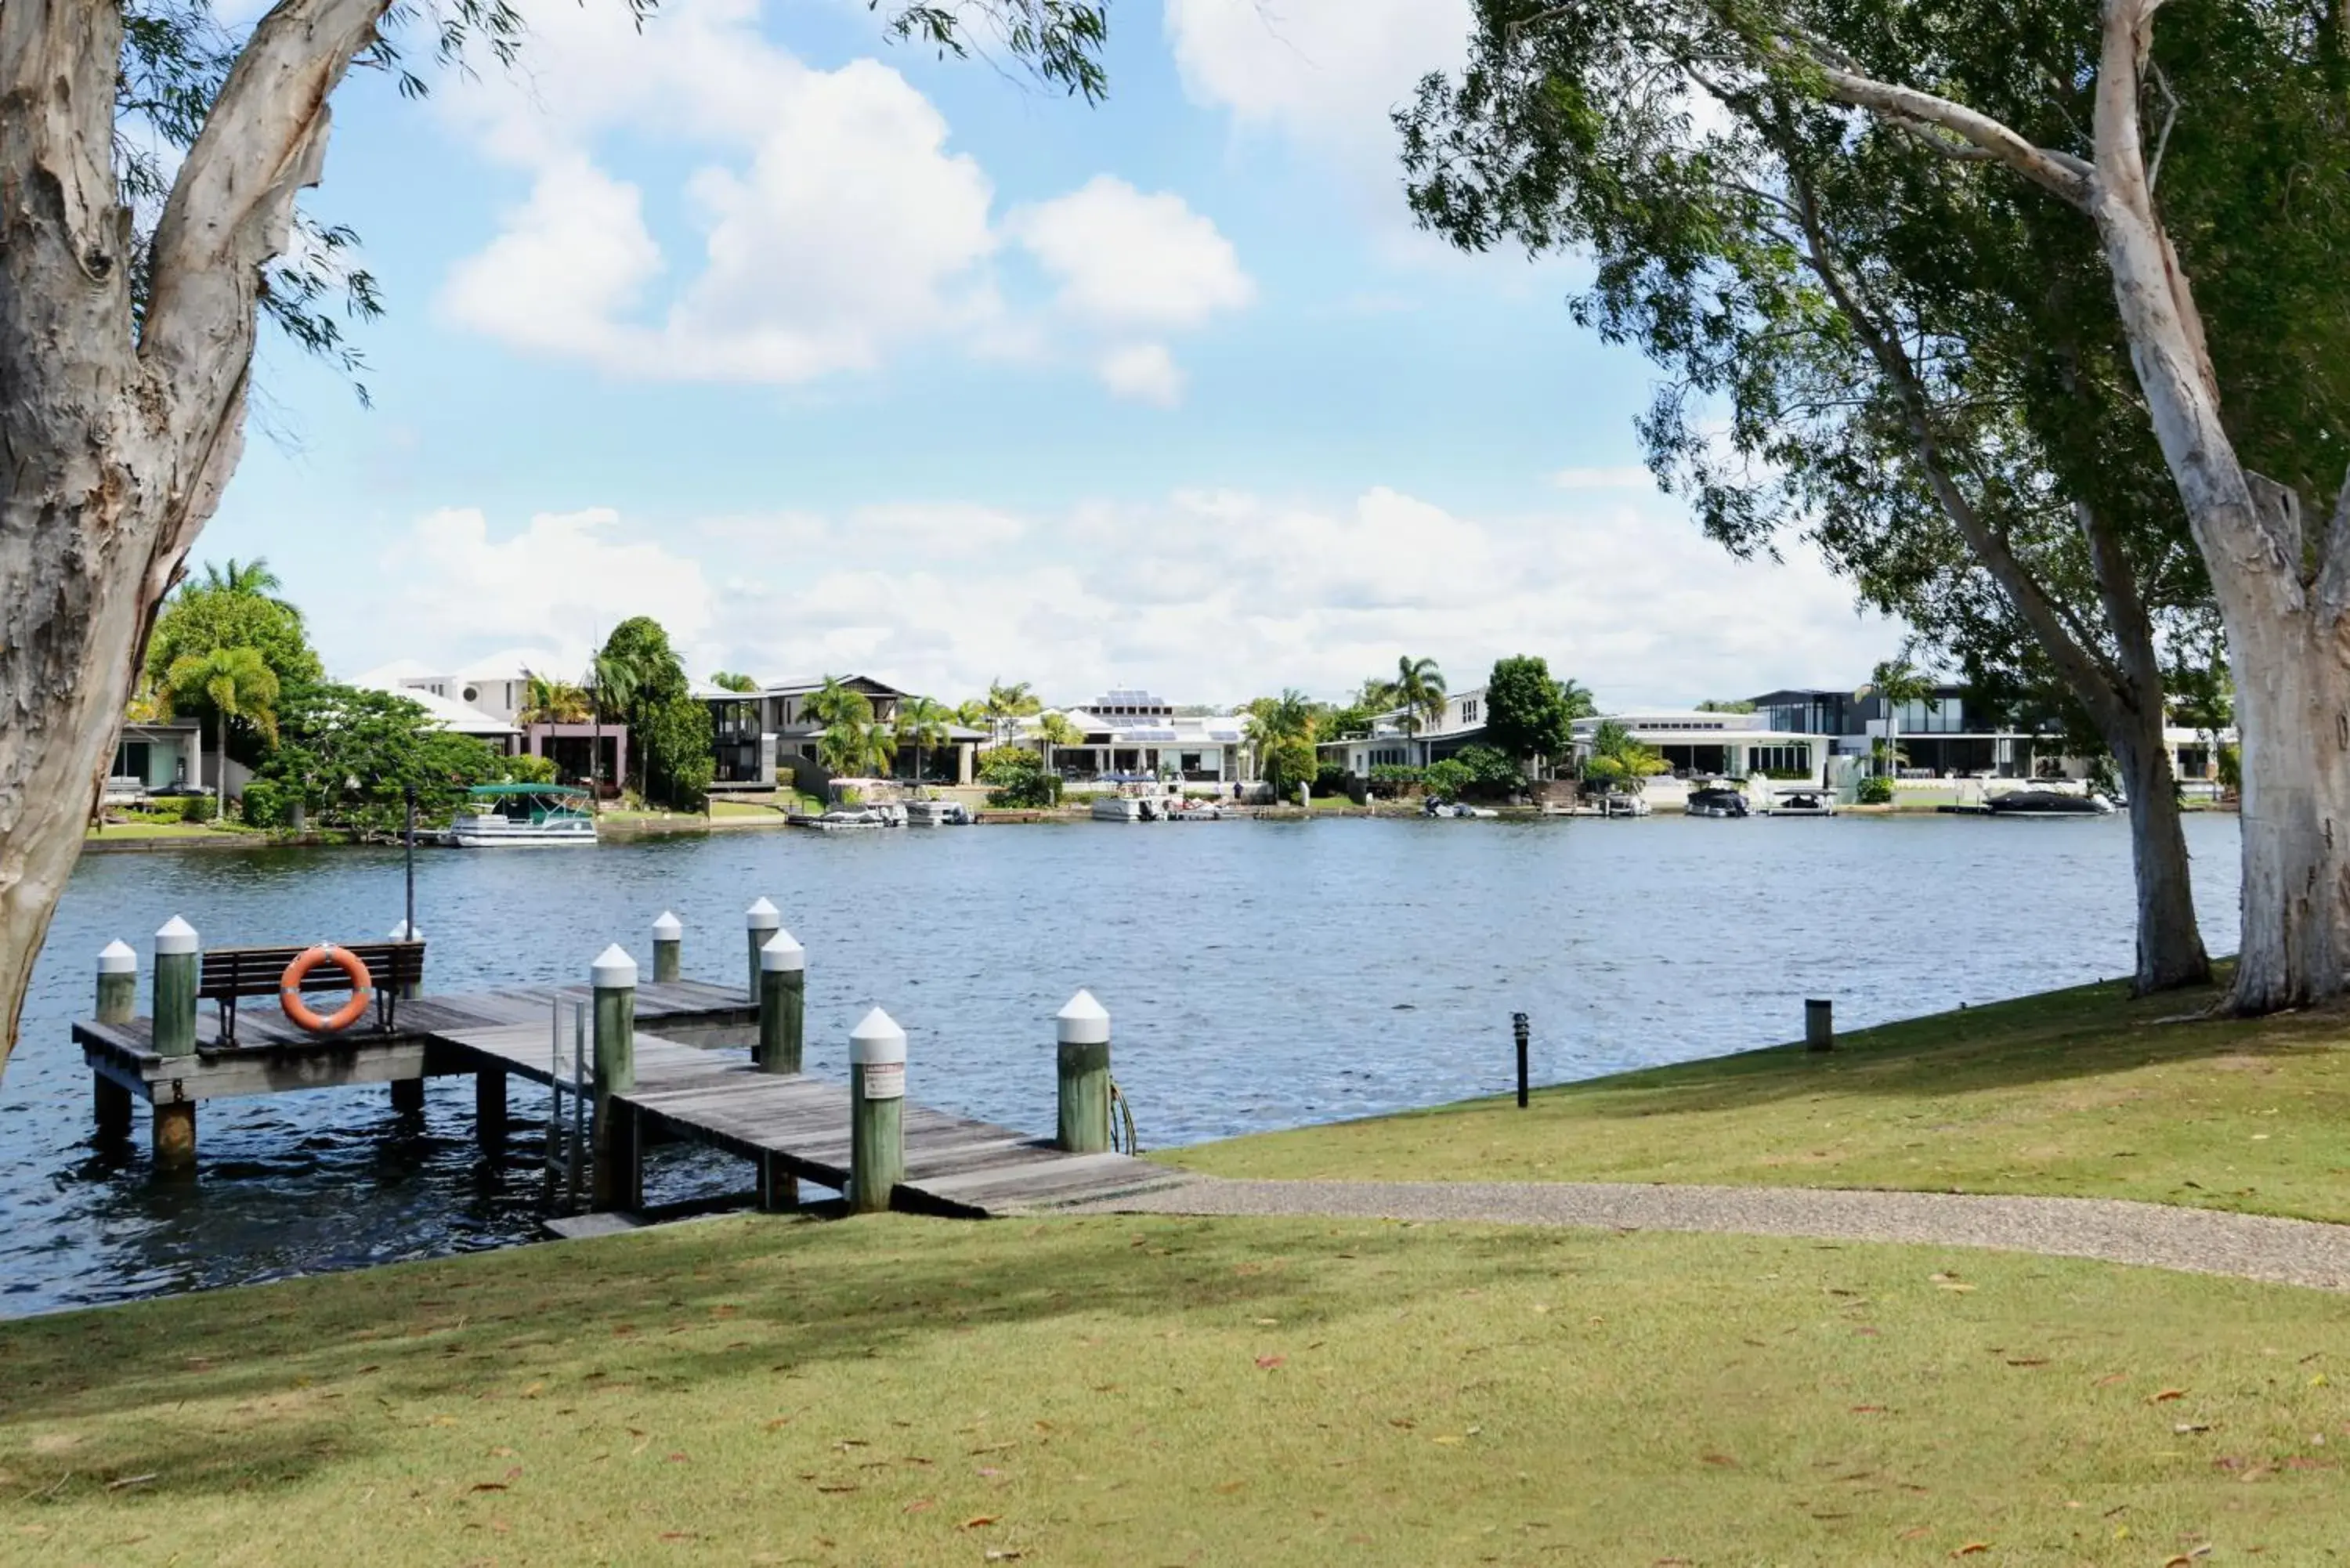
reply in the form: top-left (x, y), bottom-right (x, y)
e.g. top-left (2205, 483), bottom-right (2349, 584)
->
top-left (1398, 0), bottom-right (2322, 1006)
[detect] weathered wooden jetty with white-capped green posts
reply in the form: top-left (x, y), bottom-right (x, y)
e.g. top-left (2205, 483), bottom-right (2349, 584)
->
top-left (73, 901), bottom-right (1180, 1218)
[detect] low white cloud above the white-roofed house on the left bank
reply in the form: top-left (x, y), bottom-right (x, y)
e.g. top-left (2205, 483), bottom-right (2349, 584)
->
top-left (378, 508), bottom-right (717, 667)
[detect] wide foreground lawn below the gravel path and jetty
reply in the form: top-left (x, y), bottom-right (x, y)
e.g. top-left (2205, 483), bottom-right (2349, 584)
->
top-left (0, 1218), bottom-right (2350, 1566)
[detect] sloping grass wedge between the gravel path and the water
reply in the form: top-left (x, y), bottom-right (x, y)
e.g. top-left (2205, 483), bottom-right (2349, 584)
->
top-left (1161, 985), bottom-right (2350, 1220)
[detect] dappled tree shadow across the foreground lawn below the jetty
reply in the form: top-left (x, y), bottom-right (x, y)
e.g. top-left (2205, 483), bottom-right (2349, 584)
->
top-left (0, 1218), bottom-right (1544, 1502)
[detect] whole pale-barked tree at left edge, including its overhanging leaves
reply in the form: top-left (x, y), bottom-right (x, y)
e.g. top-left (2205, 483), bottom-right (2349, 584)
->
top-left (0, 0), bottom-right (1107, 1081)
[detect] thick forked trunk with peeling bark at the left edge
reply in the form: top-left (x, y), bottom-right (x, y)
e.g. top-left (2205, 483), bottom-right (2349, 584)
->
top-left (0, 0), bottom-right (385, 1068)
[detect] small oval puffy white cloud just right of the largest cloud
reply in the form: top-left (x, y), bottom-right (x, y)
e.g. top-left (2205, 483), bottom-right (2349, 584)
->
top-left (1008, 174), bottom-right (1257, 327)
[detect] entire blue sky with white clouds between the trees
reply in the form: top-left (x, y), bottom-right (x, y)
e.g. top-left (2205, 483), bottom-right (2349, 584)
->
top-left (197, 0), bottom-right (1899, 703)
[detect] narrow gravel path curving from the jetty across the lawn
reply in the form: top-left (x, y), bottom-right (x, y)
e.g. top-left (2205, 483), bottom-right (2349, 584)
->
top-left (1074, 1176), bottom-right (2350, 1291)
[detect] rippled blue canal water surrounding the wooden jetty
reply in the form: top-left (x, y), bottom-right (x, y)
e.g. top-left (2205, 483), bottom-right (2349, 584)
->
top-left (0, 816), bottom-right (2237, 1314)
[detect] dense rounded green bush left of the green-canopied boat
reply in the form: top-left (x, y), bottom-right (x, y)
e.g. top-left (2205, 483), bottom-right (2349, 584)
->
top-left (261, 681), bottom-right (501, 837)
